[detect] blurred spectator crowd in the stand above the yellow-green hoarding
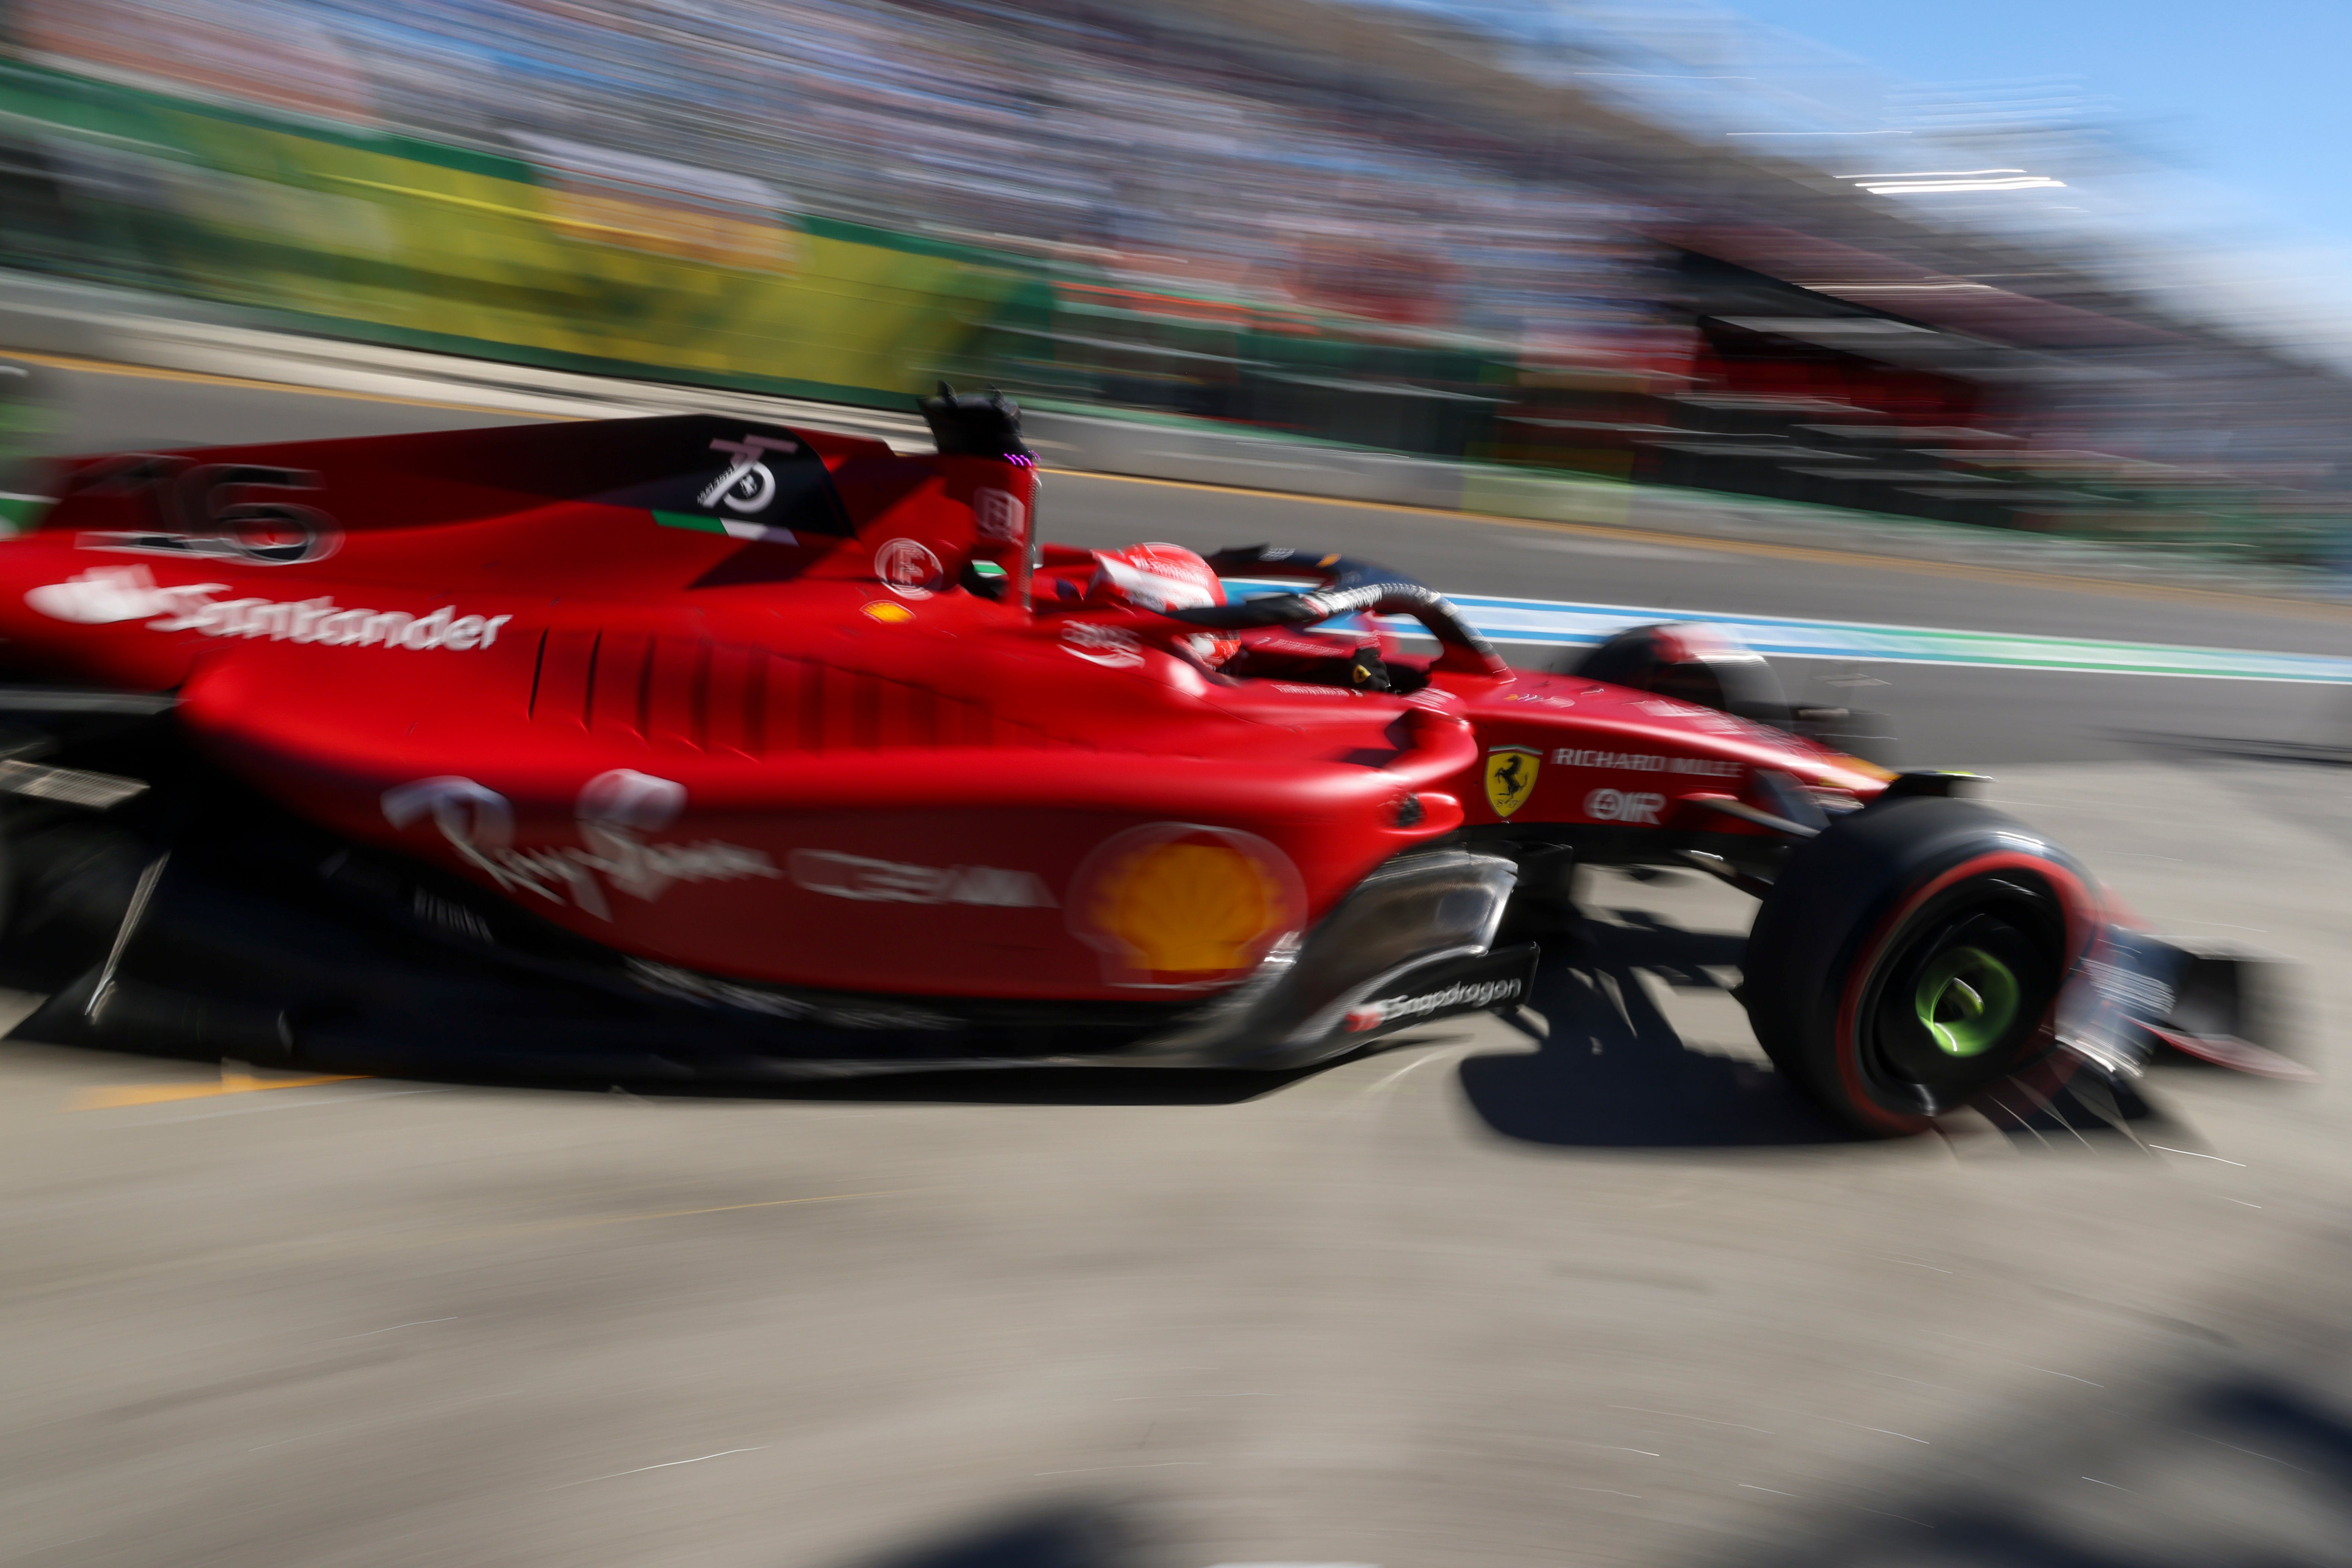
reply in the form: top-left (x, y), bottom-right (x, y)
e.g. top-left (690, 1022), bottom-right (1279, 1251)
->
top-left (14, 0), bottom-right (1658, 362)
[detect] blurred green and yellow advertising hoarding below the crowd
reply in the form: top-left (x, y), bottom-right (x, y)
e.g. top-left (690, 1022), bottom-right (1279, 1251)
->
top-left (0, 66), bottom-right (1047, 404)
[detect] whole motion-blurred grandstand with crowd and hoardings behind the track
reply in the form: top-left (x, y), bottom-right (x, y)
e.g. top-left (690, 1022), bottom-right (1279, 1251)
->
top-left (0, 0), bottom-right (2352, 564)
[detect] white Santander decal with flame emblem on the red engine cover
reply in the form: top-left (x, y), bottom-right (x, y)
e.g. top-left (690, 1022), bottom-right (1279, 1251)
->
top-left (24, 567), bottom-right (513, 654)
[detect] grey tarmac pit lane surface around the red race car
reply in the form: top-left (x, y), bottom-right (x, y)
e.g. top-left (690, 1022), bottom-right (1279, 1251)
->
top-left (0, 360), bottom-right (2352, 1568)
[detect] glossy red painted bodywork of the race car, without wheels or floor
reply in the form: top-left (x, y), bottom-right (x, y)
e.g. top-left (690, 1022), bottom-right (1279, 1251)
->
top-left (0, 421), bottom-right (1879, 999)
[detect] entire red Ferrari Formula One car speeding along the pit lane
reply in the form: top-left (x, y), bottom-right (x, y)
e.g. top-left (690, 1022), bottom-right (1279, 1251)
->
top-left (0, 392), bottom-right (2295, 1133)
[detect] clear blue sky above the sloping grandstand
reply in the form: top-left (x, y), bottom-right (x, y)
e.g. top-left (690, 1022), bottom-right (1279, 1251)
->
top-left (1371, 0), bottom-right (2352, 355)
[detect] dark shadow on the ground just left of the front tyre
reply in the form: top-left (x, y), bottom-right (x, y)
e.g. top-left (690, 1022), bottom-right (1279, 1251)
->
top-left (1461, 914), bottom-right (1860, 1149)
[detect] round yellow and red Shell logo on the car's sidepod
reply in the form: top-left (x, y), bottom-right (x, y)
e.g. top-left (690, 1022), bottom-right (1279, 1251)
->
top-left (1066, 823), bottom-right (1308, 990)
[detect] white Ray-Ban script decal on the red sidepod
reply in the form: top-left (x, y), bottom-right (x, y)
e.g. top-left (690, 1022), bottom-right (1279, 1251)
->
top-left (384, 769), bottom-right (783, 919)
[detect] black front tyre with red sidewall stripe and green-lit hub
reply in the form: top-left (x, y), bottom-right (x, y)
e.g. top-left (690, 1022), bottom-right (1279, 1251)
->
top-left (1740, 797), bottom-right (2100, 1138)
